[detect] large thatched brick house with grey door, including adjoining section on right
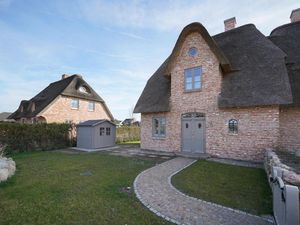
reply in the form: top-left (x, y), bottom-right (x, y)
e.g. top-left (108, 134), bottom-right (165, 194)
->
top-left (134, 9), bottom-right (300, 160)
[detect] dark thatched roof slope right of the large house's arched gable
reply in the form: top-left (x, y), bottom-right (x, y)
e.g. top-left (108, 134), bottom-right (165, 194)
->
top-left (213, 24), bottom-right (292, 107)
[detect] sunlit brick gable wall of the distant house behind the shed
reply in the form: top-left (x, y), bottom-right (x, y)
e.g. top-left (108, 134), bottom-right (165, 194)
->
top-left (38, 96), bottom-right (110, 123)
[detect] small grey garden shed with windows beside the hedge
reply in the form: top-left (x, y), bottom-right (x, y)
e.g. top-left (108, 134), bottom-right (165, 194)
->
top-left (77, 120), bottom-right (116, 149)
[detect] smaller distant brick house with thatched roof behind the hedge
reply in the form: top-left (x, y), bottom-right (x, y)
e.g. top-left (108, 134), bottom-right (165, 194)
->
top-left (9, 74), bottom-right (113, 123)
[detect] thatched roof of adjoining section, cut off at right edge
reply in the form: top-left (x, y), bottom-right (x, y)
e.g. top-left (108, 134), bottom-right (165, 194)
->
top-left (269, 21), bottom-right (300, 106)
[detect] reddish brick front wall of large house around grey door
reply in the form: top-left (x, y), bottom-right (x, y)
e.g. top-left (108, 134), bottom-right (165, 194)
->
top-left (141, 33), bottom-right (279, 160)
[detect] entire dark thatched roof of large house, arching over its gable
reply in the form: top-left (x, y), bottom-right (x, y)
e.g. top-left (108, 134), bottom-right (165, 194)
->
top-left (134, 23), bottom-right (299, 113)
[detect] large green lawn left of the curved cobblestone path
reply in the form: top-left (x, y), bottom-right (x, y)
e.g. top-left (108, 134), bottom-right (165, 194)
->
top-left (0, 152), bottom-right (168, 225)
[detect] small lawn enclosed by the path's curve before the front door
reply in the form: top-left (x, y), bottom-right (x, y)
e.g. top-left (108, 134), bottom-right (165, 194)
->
top-left (172, 160), bottom-right (272, 215)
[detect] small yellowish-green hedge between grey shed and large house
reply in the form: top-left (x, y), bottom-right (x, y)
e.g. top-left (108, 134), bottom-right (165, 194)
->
top-left (117, 126), bottom-right (141, 143)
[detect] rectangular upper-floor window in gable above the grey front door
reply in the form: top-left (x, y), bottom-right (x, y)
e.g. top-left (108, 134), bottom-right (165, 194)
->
top-left (184, 66), bottom-right (202, 92)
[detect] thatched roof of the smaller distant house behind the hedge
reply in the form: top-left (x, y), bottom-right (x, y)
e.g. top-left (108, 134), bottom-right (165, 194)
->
top-left (9, 74), bottom-right (113, 119)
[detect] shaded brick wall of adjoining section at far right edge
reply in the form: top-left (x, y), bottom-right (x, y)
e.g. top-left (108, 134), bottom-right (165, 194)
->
top-left (279, 107), bottom-right (300, 150)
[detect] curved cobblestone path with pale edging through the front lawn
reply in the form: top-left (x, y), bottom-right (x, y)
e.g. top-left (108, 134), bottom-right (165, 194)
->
top-left (134, 158), bottom-right (274, 225)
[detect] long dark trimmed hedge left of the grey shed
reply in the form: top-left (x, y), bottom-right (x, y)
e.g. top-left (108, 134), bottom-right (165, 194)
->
top-left (0, 123), bottom-right (73, 153)
